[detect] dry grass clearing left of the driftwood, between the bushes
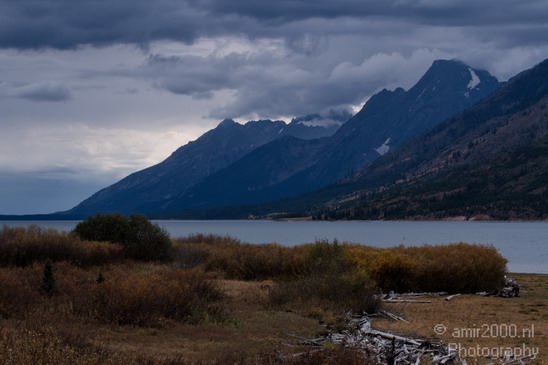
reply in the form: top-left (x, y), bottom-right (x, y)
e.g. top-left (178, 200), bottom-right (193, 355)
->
top-left (88, 280), bottom-right (323, 364)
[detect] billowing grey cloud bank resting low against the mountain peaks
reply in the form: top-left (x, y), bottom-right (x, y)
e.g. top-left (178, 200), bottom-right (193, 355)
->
top-left (134, 47), bottom-right (450, 119)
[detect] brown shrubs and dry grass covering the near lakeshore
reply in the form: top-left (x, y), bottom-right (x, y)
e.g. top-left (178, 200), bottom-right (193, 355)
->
top-left (0, 223), bottom-right (548, 365)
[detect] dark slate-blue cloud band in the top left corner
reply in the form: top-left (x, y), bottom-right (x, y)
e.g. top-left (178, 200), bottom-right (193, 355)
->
top-left (0, 0), bottom-right (203, 49)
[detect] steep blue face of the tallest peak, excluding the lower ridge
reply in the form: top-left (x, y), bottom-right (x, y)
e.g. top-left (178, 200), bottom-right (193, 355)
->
top-left (284, 60), bottom-right (499, 187)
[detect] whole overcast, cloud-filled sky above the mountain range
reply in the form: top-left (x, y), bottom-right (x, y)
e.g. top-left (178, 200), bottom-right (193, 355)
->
top-left (0, 0), bottom-right (548, 214)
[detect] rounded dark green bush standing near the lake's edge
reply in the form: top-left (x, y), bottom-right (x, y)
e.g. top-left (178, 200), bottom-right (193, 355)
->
top-left (73, 213), bottom-right (173, 261)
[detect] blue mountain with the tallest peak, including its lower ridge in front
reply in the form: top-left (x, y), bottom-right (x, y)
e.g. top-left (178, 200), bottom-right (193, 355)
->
top-left (154, 60), bottom-right (499, 216)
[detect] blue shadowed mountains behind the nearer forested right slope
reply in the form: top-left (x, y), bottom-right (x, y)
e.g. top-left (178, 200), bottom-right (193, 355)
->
top-left (67, 61), bottom-right (499, 217)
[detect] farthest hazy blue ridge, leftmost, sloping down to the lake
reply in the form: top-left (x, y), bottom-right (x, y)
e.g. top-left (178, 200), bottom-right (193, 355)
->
top-left (66, 115), bottom-right (347, 215)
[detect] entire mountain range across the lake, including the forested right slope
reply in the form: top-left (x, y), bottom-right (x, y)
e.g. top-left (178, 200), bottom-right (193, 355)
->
top-left (4, 60), bottom-right (548, 219)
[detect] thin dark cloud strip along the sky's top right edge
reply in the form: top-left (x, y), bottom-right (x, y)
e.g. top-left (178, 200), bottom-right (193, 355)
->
top-left (203, 0), bottom-right (548, 26)
